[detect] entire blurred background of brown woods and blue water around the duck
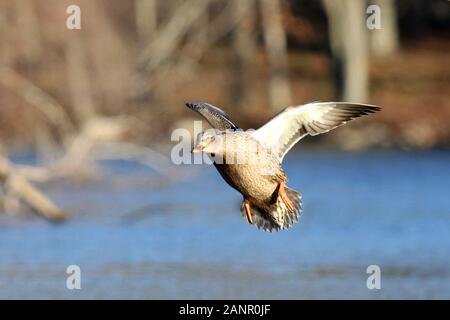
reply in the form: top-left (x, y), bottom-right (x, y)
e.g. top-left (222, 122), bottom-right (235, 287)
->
top-left (0, 0), bottom-right (450, 299)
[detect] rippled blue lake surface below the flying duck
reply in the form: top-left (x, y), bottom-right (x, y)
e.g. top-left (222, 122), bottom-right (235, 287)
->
top-left (0, 150), bottom-right (450, 299)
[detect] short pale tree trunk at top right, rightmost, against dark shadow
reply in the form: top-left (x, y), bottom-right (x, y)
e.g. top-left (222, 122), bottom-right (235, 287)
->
top-left (370, 0), bottom-right (399, 56)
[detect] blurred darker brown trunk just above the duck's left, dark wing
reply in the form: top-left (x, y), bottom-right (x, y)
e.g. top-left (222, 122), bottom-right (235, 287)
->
top-left (231, 0), bottom-right (256, 105)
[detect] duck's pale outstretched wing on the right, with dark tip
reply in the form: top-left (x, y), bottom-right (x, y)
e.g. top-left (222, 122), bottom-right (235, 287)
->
top-left (253, 102), bottom-right (381, 162)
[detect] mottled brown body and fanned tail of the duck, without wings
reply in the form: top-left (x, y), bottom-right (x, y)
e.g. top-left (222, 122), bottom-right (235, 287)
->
top-left (208, 131), bottom-right (301, 231)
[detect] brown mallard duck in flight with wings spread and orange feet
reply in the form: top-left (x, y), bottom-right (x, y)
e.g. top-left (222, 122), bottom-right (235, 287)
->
top-left (186, 102), bottom-right (381, 231)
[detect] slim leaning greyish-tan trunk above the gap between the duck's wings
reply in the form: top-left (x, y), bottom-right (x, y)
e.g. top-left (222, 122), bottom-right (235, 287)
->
top-left (260, 0), bottom-right (291, 109)
